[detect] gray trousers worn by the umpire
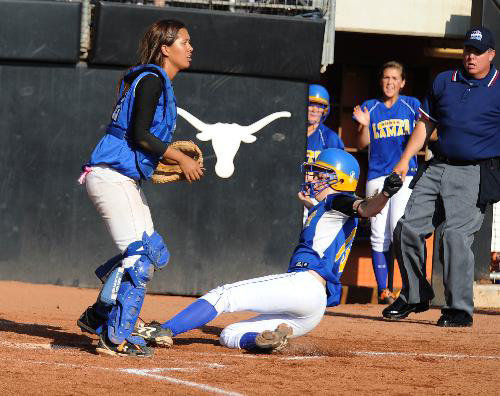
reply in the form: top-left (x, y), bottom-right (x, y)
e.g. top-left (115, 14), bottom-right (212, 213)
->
top-left (394, 161), bottom-right (484, 315)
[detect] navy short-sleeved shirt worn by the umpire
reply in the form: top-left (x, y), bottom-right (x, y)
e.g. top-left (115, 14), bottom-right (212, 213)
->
top-left (420, 65), bottom-right (500, 161)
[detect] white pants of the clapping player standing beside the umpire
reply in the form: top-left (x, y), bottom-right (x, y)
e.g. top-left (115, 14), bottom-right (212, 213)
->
top-left (366, 176), bottom-right (413, 252)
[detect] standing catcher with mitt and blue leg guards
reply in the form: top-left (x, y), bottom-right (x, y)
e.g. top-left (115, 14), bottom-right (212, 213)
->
top-left (77, 20), bottom-right (203, 357)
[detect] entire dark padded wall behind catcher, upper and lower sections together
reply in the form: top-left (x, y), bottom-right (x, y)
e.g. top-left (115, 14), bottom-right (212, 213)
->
top-left (0, 0), bottom-right (324, 295)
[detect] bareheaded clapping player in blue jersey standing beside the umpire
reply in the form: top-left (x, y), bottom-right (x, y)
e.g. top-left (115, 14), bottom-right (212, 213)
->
top-left (353, 61), bottom-right (420, 304)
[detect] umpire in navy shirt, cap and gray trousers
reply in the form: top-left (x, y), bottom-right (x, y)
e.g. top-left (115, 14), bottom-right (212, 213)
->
top-left (382, 27), bottom-right (500, 327)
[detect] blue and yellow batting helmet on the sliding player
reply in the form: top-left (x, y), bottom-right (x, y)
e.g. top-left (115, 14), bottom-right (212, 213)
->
top-left (302, 148), bottom-right (359, 196)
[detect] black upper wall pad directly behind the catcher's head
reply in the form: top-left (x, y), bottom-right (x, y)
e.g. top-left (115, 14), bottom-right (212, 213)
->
top-left (90, 2), bottom-right (325, 80)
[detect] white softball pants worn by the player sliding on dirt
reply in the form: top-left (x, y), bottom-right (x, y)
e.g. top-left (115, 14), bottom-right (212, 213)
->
top-left (201, 271), bottom-right (326, 348)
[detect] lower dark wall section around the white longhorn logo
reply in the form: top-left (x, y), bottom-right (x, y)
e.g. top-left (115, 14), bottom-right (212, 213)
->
top-left (0, 65), bottom-right (307, 295)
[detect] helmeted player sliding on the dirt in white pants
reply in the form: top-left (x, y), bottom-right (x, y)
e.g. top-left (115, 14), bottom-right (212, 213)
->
top-left (132, 149), bottom-right (402, 351)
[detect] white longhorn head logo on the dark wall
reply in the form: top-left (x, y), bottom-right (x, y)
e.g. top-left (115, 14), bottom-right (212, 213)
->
top-left (177, 107), bottom-right (292, 178)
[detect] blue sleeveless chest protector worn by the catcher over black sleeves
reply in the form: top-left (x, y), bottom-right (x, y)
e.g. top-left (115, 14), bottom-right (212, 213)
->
top-left (87, 65), bottom-right (177, 180)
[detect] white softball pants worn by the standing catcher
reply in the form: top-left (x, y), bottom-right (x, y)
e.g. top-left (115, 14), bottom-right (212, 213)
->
top-left (85, 165), bottom-right (154, 268)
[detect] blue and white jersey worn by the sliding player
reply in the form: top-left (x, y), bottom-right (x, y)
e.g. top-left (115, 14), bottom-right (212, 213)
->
top-left (288, 193), bottom-right (359, 307)
